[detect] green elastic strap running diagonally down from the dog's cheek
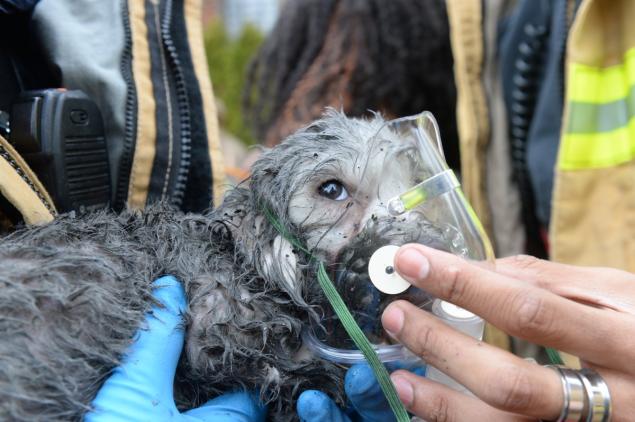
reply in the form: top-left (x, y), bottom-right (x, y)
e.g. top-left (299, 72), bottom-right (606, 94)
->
top-left (263, 207), bottom-right (410, 422)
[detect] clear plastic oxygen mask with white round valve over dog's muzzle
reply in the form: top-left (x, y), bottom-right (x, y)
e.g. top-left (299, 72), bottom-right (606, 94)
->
top-left (304, 112), bottom-right (493, 364)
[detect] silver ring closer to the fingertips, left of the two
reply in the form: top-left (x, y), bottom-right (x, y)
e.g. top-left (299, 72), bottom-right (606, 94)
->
top-left (547, 365), bottom-right (589, 422)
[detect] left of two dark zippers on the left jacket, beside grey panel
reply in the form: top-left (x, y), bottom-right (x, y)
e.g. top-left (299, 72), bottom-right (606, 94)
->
top-left (113, 0), bottom-right (137, 211)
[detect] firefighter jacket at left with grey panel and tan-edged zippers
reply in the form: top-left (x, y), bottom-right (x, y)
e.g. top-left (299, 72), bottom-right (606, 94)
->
top-left (0, 0), bottom-right (224, 227)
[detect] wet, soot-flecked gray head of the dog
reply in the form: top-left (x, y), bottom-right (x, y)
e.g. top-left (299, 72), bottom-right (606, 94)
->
top-left (237, 110), bottom-right (445, 304)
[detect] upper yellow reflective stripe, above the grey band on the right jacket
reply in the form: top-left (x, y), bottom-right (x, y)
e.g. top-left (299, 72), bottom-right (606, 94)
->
top-left (567, 48), bottom-right (635, 103)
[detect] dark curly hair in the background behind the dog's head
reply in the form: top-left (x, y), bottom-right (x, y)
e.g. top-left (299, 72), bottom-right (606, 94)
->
top-left (244, 0), bottom-right (459, 168)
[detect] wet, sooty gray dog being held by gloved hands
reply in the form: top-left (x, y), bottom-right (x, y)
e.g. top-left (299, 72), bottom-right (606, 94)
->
top-left (0, 111), bottom-right (443, 421)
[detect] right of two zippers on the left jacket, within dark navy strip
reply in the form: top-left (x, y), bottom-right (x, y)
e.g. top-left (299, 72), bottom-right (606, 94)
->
top-left (161, 0), bottom-right (192, 207)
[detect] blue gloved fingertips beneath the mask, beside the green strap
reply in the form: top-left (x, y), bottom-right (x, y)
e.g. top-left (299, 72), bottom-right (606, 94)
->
top-left (297, 364), bottom-right (425, 422)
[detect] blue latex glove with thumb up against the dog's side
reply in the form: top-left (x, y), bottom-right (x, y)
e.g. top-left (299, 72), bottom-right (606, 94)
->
top-left (85, 276), bottom-right (266, 422)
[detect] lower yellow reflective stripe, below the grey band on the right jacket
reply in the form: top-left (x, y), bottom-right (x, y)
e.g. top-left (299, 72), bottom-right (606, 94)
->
top-left (558, 118), bottom-right (635, 170)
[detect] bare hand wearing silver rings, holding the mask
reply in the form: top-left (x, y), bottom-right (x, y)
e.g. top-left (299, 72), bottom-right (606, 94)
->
top-left (382, 245), bottom-right (635, 421)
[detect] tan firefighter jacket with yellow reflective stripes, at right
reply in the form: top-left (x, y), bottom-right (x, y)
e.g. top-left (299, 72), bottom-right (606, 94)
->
top-left (448, 0), bottom-right (635, 271)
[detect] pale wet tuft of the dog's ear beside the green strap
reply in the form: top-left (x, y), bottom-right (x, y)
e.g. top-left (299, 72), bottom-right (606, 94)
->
top-left (260, 235), bottom-right (304, 302)
